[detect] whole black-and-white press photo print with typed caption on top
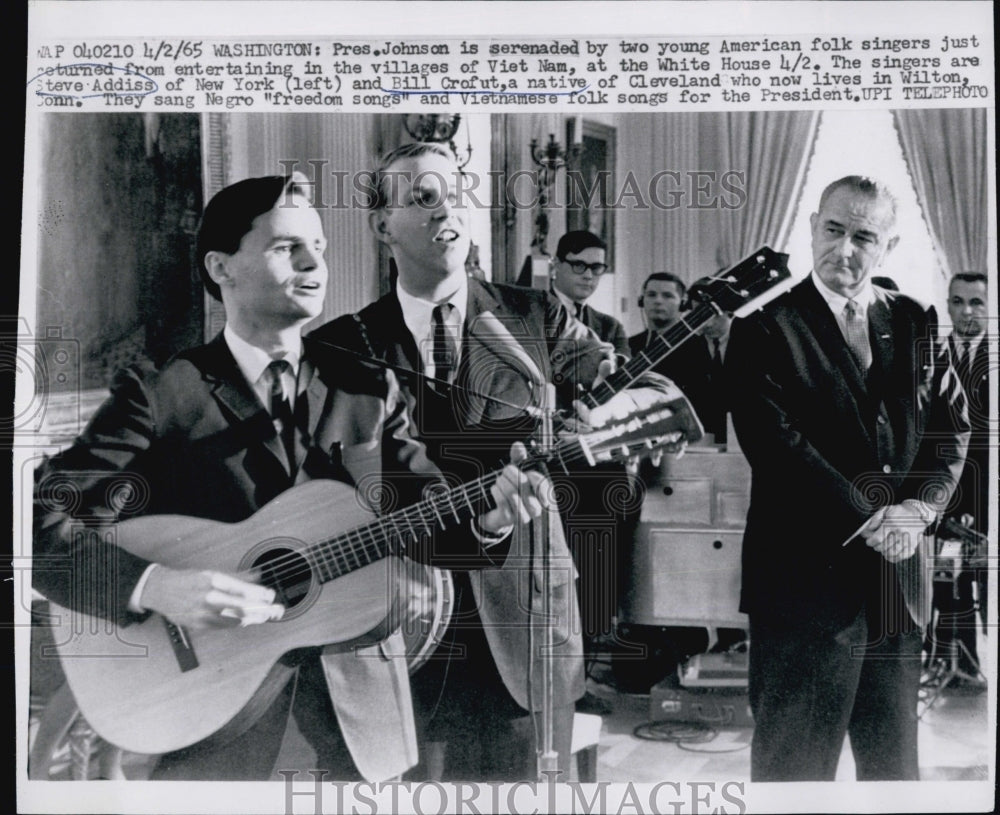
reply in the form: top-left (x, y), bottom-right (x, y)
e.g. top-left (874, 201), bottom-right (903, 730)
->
top-left (11, 3), bottom-right (1000, 815)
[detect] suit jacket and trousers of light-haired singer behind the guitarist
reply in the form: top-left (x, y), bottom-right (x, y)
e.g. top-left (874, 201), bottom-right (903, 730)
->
top-left (312, 280), bottom-right (624, 780)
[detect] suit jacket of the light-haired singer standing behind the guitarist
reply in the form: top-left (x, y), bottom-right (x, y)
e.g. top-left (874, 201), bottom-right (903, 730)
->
top-left (311, 280), bottom-right (628, 710)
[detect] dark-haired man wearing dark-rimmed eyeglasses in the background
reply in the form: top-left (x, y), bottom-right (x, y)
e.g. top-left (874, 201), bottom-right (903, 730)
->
top-left (552, 229), bottom-right (628, 356)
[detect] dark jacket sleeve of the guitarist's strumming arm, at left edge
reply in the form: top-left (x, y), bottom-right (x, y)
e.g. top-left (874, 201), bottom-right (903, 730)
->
top-left (32, 367), bottom-right (156, 624)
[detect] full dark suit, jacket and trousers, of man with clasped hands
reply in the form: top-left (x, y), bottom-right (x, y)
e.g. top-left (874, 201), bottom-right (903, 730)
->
top-left (726, 279), bottom-right (968, 780)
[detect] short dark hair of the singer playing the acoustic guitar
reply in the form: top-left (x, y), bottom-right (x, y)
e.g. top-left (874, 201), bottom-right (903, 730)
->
top-left (195, 173), bottom-right (312, 301)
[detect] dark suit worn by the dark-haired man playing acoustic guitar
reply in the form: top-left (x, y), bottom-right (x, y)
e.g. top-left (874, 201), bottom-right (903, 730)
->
top-left (34, 335), bottom-right (478, 780)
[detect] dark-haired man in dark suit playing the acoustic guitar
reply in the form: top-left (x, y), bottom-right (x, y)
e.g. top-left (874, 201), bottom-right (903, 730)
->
top-left (33, 176), bottom-right (542, 780)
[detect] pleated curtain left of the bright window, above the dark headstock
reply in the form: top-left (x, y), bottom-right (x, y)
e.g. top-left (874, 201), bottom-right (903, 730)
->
top-left (702, 111), bottom-right (820, 269)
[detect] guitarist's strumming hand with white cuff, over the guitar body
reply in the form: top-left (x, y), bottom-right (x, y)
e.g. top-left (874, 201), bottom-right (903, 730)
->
top-left (137, 564), bottom-right (285, 630)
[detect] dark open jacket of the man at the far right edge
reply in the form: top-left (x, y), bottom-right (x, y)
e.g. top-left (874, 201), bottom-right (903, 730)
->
top-left (947, 334), bottom-right (996, 533)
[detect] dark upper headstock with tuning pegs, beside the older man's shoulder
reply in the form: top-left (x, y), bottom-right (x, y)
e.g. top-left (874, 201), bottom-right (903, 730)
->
top-left (688, 246), bottom-right (792, 317)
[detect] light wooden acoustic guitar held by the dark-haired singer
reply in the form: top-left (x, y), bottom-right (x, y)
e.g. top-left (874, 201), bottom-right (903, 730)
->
top-left (52, 402), bottom-right (701, 753)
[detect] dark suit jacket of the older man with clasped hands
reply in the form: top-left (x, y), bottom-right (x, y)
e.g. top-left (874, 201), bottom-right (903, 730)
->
top-left (726, 279), bottom-right (968, 624)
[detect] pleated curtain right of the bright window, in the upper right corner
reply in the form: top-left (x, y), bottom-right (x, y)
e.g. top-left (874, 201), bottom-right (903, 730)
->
top-left (892, 108), bottom-right (989, 278)
